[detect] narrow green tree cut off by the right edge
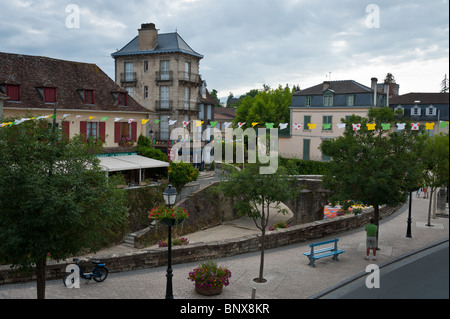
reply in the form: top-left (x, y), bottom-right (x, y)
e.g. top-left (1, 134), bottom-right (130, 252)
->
top-left (421, 133), bottom-right (449, 226)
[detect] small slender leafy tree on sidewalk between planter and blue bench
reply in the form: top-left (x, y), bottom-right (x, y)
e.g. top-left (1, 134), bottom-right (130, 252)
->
top-left (219, 163), bottom-right (294, 282)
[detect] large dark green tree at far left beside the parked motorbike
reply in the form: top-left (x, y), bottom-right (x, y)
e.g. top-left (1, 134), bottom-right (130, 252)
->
top-left (0, 120), bottom-right (126, 299)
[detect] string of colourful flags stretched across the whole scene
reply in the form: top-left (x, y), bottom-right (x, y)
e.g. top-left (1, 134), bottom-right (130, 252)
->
top-left (0, 114), bottom-right (449, 131)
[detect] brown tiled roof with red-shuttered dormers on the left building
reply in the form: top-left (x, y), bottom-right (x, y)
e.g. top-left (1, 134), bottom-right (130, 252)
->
top-left (0, 52), bottom-right (150, 113)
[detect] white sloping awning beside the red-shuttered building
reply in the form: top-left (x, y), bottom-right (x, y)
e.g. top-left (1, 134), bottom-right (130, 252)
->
top-left (99, 155), bottom-right (169, 172)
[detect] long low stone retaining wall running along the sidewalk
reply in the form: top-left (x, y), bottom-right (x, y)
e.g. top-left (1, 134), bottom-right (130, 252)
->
top-left (0, 207), bottom-right (400, 284)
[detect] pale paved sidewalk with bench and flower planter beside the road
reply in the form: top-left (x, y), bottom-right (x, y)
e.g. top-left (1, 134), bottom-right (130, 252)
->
top-left (0, 194), bottom-right (449, 299)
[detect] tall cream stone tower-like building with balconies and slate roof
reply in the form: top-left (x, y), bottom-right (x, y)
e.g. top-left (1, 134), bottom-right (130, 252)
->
top-left (112, 23), bottom-right (215, 141)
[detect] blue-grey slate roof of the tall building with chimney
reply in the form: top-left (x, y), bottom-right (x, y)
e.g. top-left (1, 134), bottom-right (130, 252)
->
top-left (111, 32), bottom-right (203, 59)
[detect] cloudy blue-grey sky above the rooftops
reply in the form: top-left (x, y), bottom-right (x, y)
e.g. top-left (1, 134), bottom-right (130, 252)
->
top-left (0, 0), bottom-right (449, 97)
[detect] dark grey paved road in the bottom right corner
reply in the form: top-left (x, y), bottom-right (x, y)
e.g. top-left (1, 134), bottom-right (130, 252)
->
top-left (322, 241), bottom-right (449, 299)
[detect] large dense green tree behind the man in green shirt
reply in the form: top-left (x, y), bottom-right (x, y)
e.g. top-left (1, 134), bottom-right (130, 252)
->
top-left (320, 107), bottom-right (424, 245)
